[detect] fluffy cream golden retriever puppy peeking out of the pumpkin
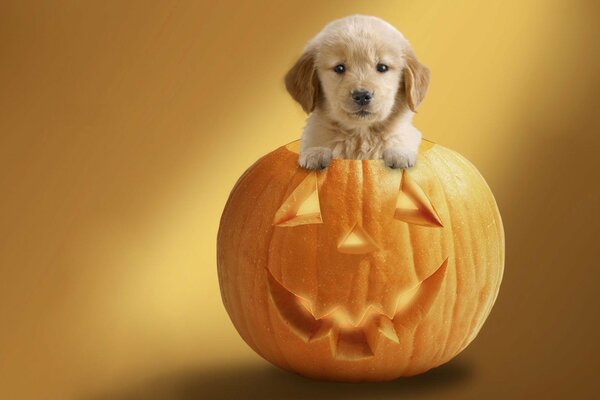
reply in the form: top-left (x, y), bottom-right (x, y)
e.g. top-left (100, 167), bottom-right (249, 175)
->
top-left (285, 15), bottom-right (429, 169)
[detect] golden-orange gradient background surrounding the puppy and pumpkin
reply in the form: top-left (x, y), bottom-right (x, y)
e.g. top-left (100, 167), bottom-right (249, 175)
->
top-left (0, 0), bottom-right (600, 400)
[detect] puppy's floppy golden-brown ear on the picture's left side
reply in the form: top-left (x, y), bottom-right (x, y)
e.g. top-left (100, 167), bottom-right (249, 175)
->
top-left (284, 49), bottom-right (321, 114)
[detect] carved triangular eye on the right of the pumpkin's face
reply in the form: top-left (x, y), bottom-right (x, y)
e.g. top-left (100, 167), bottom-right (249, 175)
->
top-left (394, 172), bottom-right (443, 226)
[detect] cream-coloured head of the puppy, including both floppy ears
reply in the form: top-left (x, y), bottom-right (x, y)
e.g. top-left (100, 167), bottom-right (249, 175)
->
top-left (285, 15), bottom-right (429, 126)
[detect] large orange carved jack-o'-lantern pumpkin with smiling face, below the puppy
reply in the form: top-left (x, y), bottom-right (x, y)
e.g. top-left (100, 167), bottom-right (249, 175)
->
top-left (217, 140), bottom-right (504, 381)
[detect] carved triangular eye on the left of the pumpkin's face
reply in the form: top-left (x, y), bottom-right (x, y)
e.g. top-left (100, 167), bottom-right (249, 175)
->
top-left (273, 172), bottom-right (323, 226)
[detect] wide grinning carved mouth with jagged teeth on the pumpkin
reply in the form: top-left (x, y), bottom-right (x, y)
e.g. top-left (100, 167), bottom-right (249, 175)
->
top-left (267, 258), bottom-right (448, 360)
